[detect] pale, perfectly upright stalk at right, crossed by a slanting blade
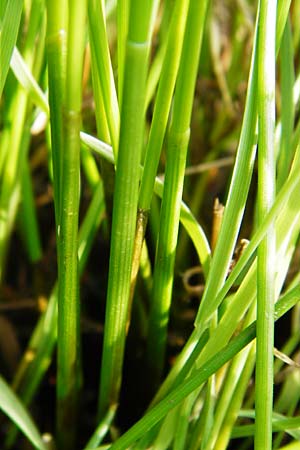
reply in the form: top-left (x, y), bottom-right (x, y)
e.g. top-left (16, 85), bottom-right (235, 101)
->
top-left (254, 0), bottom-right (276, 450)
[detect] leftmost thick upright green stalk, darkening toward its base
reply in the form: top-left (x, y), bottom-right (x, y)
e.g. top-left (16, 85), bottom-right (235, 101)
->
top-left (57, 1), bottom-right (86, 449)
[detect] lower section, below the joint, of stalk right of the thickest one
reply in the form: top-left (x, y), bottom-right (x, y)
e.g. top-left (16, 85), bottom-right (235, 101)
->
top-left (148, 126), bottom-right (189, 386)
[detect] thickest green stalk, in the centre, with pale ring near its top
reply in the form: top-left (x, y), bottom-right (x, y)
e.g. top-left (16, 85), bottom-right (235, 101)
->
top-left (99, 0), bottom-right (155, 417)
